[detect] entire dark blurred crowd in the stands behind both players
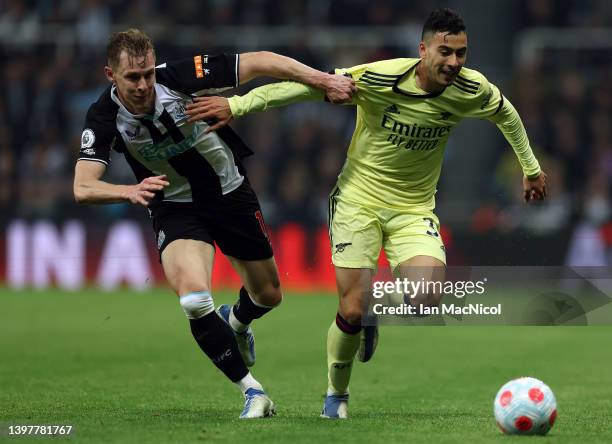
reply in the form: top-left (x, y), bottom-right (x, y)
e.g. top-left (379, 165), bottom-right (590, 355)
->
top-left (0, 0), bottom-right (612, 239)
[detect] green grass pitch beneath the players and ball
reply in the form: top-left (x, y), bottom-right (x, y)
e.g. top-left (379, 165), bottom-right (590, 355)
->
top-left (0, 289), bottom-right (612, 443)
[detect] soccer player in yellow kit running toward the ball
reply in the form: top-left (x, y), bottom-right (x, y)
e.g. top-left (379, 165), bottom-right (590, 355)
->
top-left (188, 9), bottom-right (546, 418)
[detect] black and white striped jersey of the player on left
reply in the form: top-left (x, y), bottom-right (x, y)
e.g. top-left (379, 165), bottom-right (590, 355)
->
top-left (79, 54), bottom-right (252, 202)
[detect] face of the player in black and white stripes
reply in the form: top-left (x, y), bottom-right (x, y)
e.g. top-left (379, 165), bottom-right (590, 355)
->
top-left (105, 51), bottom-right (155, 114)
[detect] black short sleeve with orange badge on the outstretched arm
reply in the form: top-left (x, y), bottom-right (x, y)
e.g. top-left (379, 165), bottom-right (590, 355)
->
top-left (155, 54), bottom-right (240, 95)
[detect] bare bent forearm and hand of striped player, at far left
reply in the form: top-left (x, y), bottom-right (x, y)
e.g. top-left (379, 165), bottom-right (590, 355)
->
top-left (74, 160), bottom-right (170, 207)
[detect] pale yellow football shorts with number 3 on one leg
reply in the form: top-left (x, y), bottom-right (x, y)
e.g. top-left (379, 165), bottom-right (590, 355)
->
top-left (328, 188), bottom-right (446, 269)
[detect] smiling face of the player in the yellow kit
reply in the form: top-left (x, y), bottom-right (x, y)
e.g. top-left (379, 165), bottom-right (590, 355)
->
top-left (419, 32), bottom-right (467, 89)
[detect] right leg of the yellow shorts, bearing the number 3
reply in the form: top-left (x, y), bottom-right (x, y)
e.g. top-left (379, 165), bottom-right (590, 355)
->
top-left (383, 210), bottom-right (446, 270)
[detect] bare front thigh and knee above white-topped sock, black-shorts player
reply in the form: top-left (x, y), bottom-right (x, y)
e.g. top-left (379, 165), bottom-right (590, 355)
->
top-left (161, 239), bottom-right (215, 296)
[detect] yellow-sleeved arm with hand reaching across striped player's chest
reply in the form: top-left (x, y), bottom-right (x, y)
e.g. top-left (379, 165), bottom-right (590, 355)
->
top-left (186, 82), bottom-right (325, 132)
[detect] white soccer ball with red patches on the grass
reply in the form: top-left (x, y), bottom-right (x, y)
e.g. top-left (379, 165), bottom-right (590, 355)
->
top-left (493, 378), bottom-right (557, 435)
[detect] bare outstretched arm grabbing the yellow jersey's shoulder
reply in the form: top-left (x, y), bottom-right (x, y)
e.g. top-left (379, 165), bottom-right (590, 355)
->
top-left (239, 51), bottom-right (357, 103)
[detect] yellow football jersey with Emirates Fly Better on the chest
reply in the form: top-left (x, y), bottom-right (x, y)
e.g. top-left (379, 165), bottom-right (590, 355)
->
top-left (336, 58), bottom-right (504, 211)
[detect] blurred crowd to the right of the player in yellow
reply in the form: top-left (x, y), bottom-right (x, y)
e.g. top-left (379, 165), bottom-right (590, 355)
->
top-left (480, 1), bottom-right (612, 239)
